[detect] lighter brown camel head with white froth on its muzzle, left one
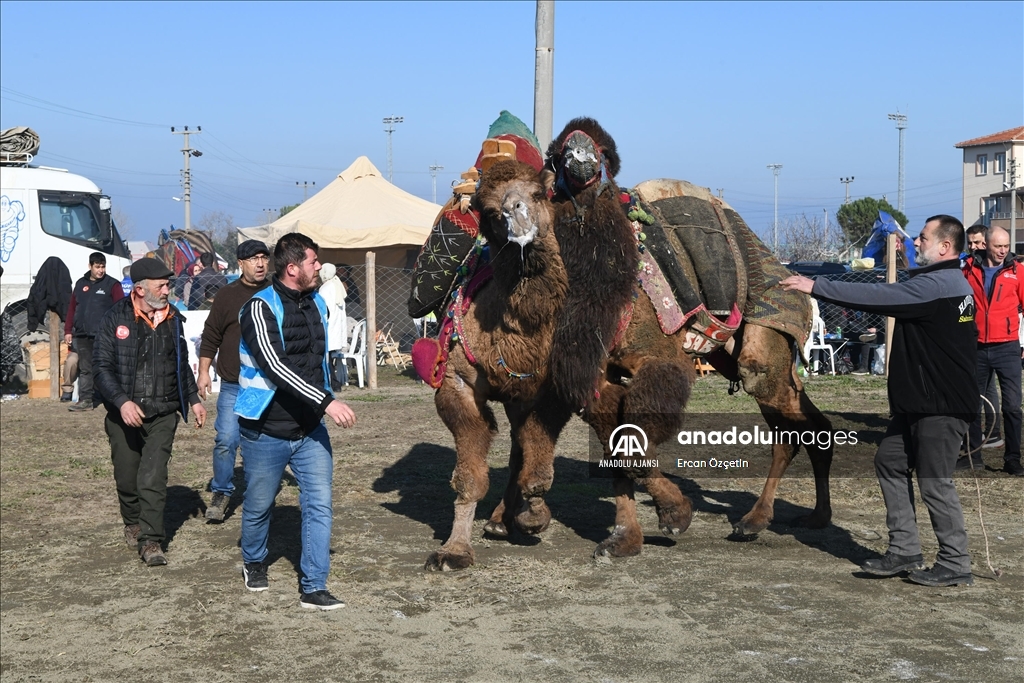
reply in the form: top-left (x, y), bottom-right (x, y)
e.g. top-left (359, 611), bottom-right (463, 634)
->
top-left (473, 161), bottom-right (553, 250)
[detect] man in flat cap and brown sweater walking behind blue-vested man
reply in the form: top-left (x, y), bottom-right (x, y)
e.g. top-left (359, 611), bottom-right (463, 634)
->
top-left (198, 240), bottom-right (270, 523)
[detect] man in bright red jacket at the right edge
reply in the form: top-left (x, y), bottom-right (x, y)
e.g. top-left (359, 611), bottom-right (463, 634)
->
top-left (957, 226), bottom-right (1024, 476)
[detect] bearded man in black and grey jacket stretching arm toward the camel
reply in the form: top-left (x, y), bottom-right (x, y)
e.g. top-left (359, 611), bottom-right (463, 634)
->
top-left (781, 215), bottom-right (978, 586)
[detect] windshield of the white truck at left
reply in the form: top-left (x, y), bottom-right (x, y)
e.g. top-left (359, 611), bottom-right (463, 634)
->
top-left (39, 190), bottom-right (127, 256)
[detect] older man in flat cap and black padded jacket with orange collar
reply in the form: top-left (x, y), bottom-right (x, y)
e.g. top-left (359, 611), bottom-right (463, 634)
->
top-left (93, 258), bottom-right (206, 566)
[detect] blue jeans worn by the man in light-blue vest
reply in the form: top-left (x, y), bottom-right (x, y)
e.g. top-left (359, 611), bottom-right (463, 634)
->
top-left (239, 423), bottom-right (334, 593)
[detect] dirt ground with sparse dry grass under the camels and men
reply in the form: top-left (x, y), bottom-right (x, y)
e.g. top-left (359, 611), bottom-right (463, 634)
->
top-left (0, 371), bottom-right (1024, 683)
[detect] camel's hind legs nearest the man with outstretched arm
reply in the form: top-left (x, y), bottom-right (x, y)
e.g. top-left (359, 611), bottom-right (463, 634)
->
top-left (734, 325), bottom-right (833, 536)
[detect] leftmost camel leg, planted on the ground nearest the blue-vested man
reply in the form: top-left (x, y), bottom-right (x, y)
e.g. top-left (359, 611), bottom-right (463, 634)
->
top-left (425, 366), bottom-right (497, 571)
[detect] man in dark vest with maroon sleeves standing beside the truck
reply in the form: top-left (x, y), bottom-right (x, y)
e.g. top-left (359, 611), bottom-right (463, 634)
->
top-left (65, 251), bottom-right (125, 411)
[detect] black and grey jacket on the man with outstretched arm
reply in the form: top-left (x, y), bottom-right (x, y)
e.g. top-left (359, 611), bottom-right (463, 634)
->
top-left (811, 259), bottom-right (978, 422)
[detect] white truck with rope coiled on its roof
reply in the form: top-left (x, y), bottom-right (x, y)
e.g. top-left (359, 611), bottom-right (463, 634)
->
top-left (0, 129), bottom-right (131, 389)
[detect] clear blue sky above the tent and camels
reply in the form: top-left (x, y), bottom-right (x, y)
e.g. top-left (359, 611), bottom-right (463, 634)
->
top-left (0, 1), bottom-right (1024, 240)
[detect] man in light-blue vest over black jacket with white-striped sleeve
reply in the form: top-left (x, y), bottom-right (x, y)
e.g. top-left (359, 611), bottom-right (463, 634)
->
top-left (234, 232), bottom-right (355, 609)
